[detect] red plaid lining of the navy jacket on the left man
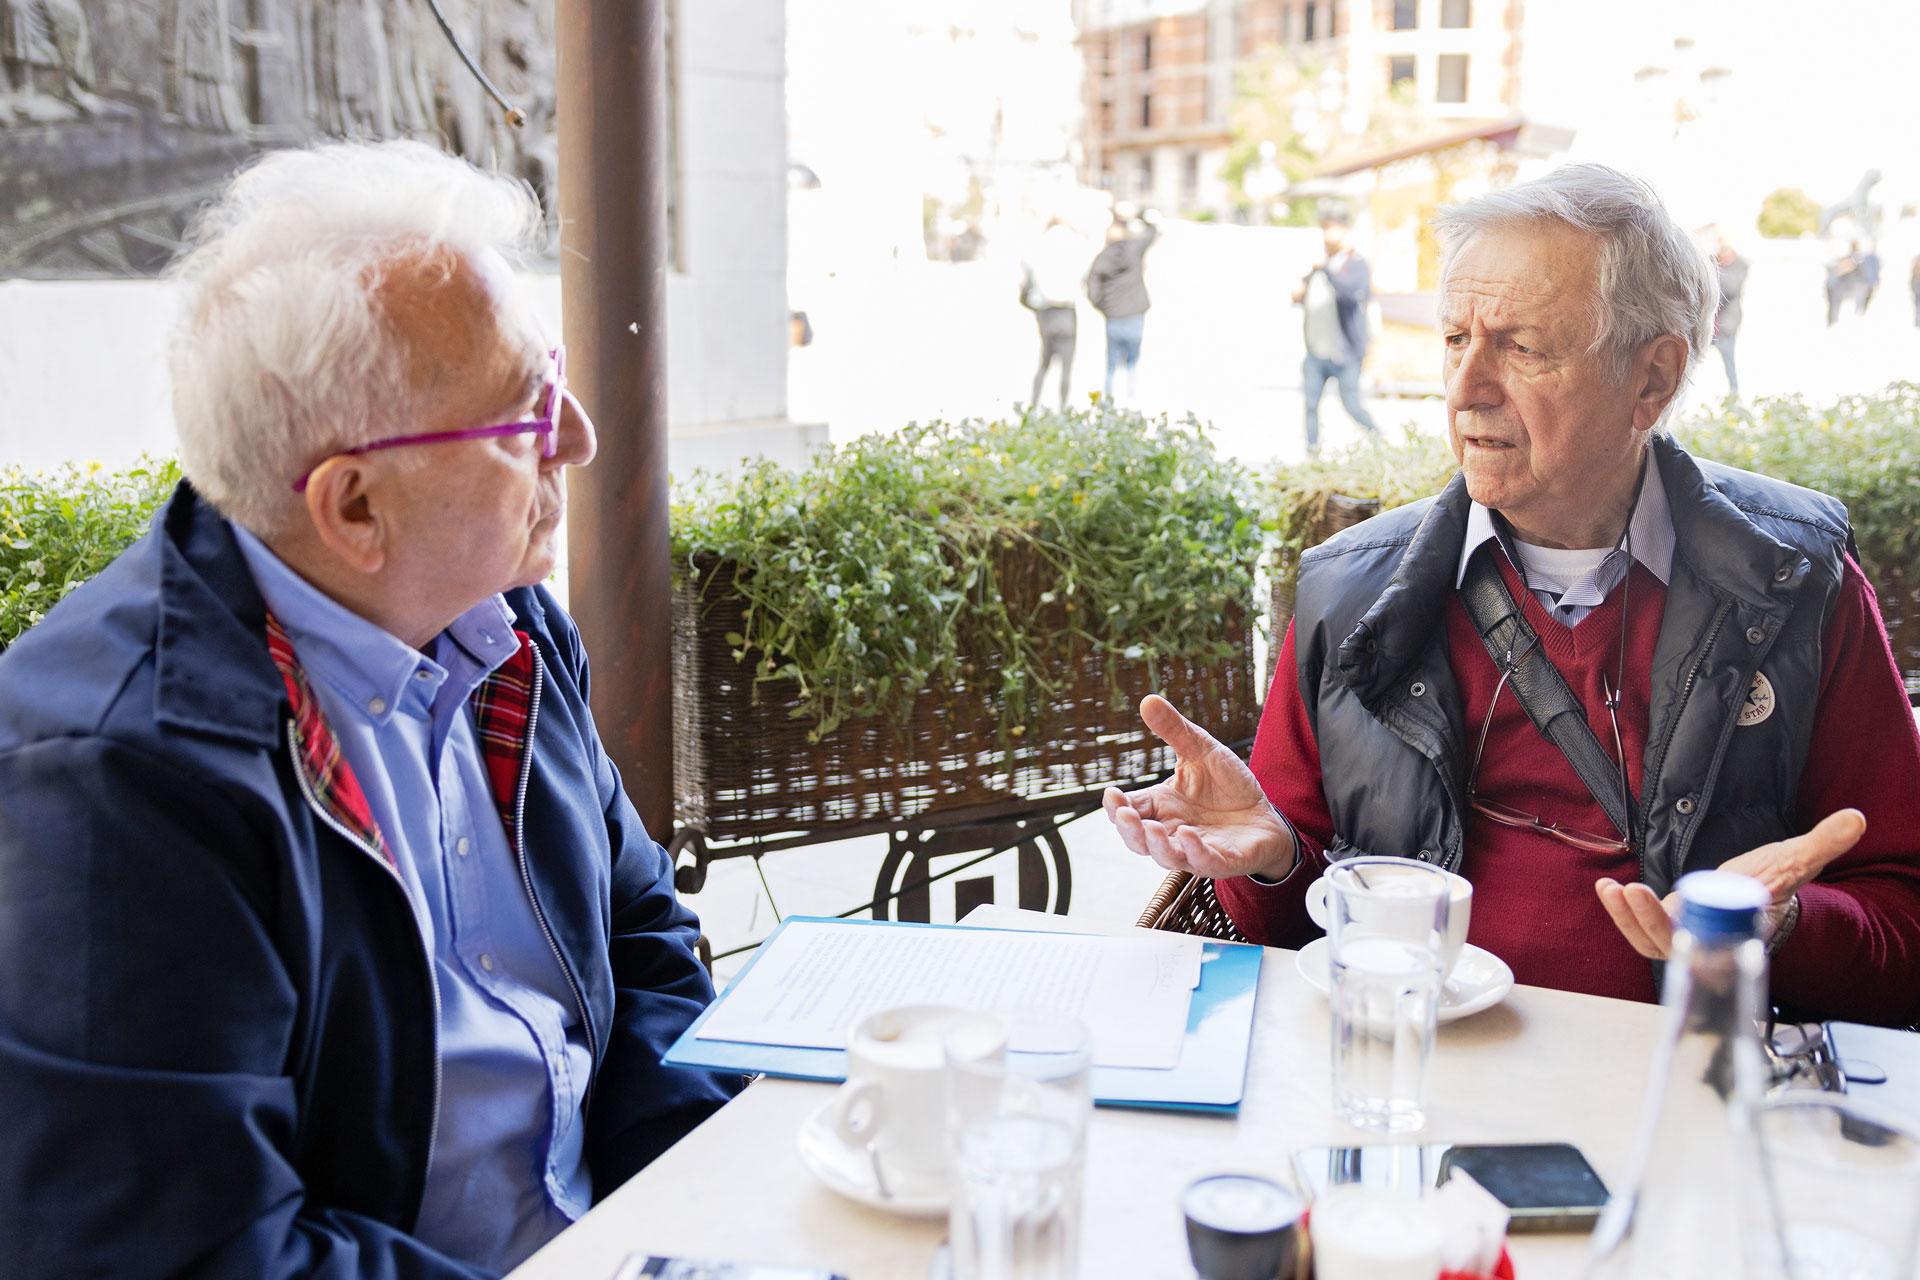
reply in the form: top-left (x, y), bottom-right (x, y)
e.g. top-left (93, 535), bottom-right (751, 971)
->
top-left (267, 612), bottom-right (536, 867)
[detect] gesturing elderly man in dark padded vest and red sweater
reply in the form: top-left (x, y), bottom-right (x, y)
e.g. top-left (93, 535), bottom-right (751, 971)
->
top-left (1106, 165), bottom-right (1920, 1023)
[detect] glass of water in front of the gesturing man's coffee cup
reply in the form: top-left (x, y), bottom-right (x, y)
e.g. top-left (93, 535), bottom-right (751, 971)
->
top-left (1327, 858), bottom-right (1452, 1132)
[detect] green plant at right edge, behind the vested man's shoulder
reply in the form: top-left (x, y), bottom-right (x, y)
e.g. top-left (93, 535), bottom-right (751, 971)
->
top-left (1674, 382), bottom-right (1920, 591)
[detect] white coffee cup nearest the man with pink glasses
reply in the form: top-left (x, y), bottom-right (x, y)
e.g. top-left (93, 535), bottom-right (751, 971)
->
top-left (828, 1004), bottom-right (1006, 1178)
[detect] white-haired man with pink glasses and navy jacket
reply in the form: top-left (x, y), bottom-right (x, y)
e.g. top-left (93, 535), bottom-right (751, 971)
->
top-left (0, 144), bottom-right (739, 1278)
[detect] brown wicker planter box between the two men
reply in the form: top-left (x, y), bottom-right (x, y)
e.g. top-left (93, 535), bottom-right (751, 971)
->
top-left (674, 564), bottom-right (1260, 842)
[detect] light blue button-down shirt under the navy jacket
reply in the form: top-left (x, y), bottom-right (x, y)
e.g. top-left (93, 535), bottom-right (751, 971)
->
top-left (234, 526), bottom-right (593, 1270)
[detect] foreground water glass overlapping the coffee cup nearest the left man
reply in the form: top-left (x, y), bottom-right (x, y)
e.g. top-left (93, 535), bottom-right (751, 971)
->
top-left (947, 1013), bottom-right (1092, 1280)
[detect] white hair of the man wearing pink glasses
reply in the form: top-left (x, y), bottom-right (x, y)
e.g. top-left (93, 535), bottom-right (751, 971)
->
top-left (169, 142), bottom-right (540, 535)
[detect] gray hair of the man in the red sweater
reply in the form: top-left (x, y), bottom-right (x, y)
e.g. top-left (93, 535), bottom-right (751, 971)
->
top-left (1434, 165), bottom-right (1720, 395)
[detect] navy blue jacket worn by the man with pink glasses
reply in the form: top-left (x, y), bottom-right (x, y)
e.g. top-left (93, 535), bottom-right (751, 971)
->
top-left (0, 486), bottom-right (737, 1280)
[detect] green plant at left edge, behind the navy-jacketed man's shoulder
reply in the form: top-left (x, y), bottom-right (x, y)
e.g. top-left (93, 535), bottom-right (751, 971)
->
top-left (0, 457), bottom-right (180, 649)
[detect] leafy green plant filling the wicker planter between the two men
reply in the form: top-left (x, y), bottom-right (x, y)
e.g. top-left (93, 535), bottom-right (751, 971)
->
top-left (672, 401), bottom-right (1261, 741)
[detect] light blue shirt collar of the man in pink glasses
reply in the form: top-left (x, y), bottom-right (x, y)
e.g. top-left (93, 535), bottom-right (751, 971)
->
top-left (232, 524), bottom-right (518, 723)
